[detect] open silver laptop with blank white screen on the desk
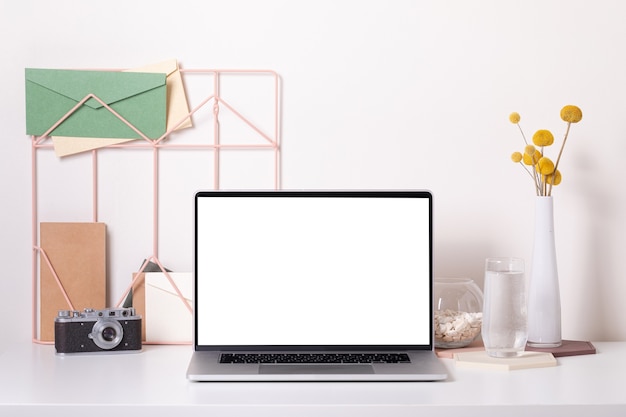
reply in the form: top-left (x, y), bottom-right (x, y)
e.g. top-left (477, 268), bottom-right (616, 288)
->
top-left (187, 191), bottom-right (447, 381)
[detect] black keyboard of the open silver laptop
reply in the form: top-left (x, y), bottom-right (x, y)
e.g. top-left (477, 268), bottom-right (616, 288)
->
top-left (220, 353), bottom-right (411, 363)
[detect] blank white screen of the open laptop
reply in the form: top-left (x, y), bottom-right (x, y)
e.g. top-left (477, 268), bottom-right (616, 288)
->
top-left (196, 192), bottom-right (432, 347)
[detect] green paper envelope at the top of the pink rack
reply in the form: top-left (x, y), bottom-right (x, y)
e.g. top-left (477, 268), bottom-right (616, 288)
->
top-left (26, 68), bottom-right (167, 139)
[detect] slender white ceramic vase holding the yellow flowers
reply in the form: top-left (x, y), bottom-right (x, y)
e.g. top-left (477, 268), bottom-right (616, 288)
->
top-left (528, 196), bottom-right (561, 348)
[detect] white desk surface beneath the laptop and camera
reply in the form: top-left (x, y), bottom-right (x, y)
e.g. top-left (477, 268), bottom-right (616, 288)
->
top-left (0, 335), bottom-right (626, 417)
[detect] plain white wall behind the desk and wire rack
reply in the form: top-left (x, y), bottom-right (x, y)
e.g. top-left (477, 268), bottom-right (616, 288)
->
top-left (0, 0), bottom-right (626, 340)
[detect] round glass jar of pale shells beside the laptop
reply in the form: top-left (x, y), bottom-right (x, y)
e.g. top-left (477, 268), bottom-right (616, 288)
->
top-left (434, 278), bottom-right (483, 348)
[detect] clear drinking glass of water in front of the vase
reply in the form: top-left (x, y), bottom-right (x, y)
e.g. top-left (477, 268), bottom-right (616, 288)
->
top-left (482, 258), bottom-right (528, 358)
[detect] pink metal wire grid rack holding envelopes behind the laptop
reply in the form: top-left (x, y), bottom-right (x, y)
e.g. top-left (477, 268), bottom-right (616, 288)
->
top-left (31, 68), bottom-right (281, 344)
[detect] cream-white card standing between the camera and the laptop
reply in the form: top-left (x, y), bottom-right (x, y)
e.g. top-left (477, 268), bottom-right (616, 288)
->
top-left (143, 272), bottom-right (193, 343)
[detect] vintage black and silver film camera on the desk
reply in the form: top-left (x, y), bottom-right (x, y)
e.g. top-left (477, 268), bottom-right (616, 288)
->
top-left (54, 308), bottom-right (141, 354)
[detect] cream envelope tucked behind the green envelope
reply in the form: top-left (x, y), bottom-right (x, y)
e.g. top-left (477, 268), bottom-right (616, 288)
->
top-left (52, 59), bottom-right (193, 157)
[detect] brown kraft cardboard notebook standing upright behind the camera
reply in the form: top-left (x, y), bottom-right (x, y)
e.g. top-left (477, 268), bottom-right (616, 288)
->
top-left (39, 223), bottom-right (106, 341)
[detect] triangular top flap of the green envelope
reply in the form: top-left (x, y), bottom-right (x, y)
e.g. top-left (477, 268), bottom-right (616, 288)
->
top-left (26, 68), bottom-right (166, 109)
